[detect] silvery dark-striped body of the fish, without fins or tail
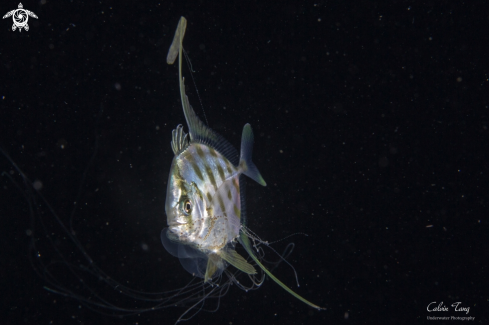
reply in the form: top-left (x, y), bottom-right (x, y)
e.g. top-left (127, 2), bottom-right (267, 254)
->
top-left (165, 135), bottom-right (241, 249)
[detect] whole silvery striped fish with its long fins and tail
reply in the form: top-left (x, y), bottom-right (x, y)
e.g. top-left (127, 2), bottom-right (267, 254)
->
top-left (161, 17), bottom-right (322, 309)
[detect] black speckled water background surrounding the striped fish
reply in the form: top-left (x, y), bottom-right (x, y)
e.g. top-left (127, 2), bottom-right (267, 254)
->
top-left (0, 1), bottom-right (489, 324)
